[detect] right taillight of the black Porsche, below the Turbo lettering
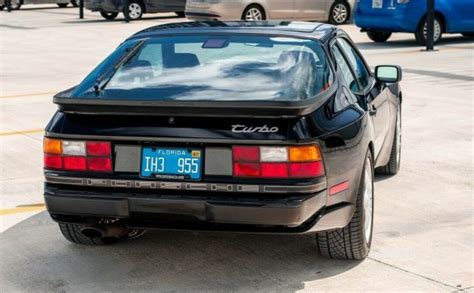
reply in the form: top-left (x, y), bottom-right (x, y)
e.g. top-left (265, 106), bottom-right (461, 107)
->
top-left (232, 145), bottom-right (324, 179)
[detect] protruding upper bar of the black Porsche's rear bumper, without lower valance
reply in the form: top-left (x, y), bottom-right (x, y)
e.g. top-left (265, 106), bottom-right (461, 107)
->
top-left (45, 191), bottom-right (326, 227)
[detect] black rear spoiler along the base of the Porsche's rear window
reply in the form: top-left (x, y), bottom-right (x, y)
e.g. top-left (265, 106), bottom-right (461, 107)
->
top-left (53, 84), bottom-right (337, 118)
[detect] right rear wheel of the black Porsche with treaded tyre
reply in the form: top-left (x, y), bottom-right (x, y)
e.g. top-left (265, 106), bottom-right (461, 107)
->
top-left (316, 150), bottom-right (374, 259)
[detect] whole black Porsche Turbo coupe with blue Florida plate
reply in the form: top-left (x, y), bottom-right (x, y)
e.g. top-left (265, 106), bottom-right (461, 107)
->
top-left (44, 22), bottom-right (402, 259)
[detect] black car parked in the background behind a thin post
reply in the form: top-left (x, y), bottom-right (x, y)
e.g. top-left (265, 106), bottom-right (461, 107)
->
top-left (84, 0), bottom-right (186, 20)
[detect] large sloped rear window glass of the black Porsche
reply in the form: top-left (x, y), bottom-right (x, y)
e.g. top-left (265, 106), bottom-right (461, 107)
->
top-left (74, 35), bottom-right (333, 101)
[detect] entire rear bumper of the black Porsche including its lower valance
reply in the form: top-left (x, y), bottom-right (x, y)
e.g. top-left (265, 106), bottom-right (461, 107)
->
top-left (45, 182), bottom-right (353, 233)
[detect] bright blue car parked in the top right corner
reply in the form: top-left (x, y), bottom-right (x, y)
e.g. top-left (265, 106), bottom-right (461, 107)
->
top-left (354, 0), bottom-right (474, 45)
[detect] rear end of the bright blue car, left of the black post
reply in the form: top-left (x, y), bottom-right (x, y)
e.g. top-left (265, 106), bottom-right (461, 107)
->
top-left (354, 0), bottom-right (426, 32)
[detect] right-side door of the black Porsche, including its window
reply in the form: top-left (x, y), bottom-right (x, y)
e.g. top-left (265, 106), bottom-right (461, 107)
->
top-left (337, 37), bottom-right (393, 158)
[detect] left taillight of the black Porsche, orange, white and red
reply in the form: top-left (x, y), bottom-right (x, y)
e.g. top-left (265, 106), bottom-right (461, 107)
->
top-left (43, 137), bottom-right (112, 172)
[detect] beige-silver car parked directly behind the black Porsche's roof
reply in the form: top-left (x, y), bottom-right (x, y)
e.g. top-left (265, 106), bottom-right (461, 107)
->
top-left (186, 0), bottom-right (355, 24)
